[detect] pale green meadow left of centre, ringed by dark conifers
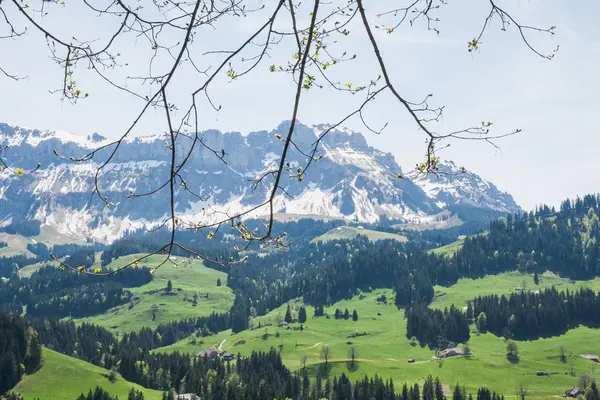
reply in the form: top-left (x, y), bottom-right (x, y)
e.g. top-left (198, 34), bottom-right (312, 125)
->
top-left (76, 254), bottom-right (235, 332)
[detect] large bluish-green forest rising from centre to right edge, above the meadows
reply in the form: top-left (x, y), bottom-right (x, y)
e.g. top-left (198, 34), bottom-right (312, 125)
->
top-left (227, 195), bottom-right (600, 334)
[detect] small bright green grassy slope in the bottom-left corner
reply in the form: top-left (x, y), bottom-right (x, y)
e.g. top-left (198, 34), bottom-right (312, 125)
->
top-left (13, 348), bottom-right (162, 400)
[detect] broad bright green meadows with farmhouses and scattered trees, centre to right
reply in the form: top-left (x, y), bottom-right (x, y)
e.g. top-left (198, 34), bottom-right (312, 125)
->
top-left (159, 273), bottom-right (600, 398)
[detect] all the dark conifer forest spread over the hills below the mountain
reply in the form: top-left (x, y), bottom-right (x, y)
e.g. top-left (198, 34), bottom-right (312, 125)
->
top-left (0, 196), bottom-right (600, 400)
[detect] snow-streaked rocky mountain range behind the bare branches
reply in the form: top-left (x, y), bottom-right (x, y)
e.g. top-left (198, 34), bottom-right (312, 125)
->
top-left (0, 122), bottom-right (519, 242)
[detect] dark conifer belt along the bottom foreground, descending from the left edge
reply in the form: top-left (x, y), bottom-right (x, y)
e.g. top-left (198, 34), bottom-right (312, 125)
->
top-left (0, 313), bottom-right (508, 400)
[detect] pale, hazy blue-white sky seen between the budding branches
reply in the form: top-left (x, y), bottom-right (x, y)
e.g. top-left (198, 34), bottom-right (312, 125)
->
top-left (0, 0), bottom-right (600, 209)
